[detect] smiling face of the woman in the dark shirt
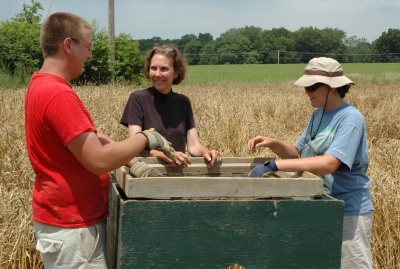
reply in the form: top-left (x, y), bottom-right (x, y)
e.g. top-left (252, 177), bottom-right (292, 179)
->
top-left (149, 54), bottom-right (178, 94)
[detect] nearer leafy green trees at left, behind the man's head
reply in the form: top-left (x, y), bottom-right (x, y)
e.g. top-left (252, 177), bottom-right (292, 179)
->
top-left (0, 0), bottom-right (144, 84)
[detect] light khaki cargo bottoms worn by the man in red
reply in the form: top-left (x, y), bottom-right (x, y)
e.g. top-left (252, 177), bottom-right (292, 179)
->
top-left (34, 221), bottom-right (107, 269)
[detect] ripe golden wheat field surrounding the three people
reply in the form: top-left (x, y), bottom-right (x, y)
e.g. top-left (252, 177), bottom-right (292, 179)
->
top-left (0, 83), bottom-right (400, 269)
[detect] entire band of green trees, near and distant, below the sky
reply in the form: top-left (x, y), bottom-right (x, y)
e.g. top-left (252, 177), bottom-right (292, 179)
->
top-left (0, 0), bottom-right (400, 83)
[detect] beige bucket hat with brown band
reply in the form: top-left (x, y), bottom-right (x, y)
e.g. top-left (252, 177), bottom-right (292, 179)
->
top-left (294, 57), bottom-right (355, 88)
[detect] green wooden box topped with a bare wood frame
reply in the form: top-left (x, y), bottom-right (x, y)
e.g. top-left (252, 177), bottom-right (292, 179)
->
top-left (107, 158), bottom-right (344, 269)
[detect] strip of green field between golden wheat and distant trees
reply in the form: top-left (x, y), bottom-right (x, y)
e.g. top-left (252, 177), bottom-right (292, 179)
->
top-left (185, 63), bottom-right (400, 85)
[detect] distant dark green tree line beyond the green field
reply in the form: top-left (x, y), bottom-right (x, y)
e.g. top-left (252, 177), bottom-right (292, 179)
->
top-left (138, 26), bottom-right (400, 65)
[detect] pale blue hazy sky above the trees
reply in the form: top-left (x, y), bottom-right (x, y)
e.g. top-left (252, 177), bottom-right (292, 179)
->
top-left (0, 0), bottom-right (400, 42)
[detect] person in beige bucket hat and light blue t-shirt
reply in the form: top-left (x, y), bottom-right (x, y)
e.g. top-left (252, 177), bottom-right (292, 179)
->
top-left (248, 57), bottom-right (373, 269)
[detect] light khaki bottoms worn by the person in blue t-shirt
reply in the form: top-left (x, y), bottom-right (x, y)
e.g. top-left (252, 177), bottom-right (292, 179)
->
top-left (340, 213), bottom-right (373, 269)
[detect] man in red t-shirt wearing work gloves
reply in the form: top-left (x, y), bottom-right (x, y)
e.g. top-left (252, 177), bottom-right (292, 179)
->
top-left (25, 13), bottom-right (174, 268)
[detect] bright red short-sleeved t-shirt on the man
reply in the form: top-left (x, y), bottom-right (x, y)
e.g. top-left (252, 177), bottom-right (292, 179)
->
top-left (25, 73), bottom-right (110, 228)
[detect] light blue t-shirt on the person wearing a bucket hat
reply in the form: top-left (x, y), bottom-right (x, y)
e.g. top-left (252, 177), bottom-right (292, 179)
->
top-left (295, 104), bottom-right (373, 215)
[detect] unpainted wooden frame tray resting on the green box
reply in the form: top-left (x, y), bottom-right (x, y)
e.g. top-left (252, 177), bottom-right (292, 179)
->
top-left (114, 158), bottom-right (322, 199)
